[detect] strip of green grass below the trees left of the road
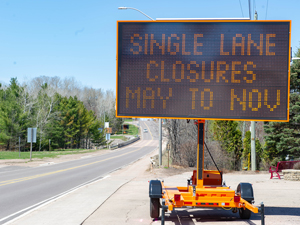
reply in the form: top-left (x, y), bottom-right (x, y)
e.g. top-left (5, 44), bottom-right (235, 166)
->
top-left (0, 149), bottom-right (100, 160)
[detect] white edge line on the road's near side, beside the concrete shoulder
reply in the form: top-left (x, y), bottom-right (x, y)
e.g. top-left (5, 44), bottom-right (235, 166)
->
top-left (0, 175), bottom-right (110, 225)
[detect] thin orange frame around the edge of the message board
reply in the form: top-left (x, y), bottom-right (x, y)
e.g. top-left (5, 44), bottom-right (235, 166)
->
top-left (116, 19), bottom-right (291, 122)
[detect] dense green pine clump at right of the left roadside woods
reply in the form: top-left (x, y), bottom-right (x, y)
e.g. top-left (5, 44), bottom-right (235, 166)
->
top-left (47, 94), bottom-right (105, 148)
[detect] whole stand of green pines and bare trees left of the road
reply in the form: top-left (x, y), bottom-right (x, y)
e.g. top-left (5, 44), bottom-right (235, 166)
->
top-left (0, 76), bottom-right (114, 150)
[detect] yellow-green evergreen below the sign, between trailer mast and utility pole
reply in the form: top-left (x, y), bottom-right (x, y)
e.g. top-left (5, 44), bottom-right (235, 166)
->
top-left (213, 120), bottom-right (242, 170)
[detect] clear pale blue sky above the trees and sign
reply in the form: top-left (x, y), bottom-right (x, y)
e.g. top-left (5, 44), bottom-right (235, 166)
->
top-left (0, 0), bottom-right (300, 92)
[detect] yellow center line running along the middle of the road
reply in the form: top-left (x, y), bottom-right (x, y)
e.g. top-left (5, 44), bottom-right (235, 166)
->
top-left (0, 140), bottom-right (151, 187)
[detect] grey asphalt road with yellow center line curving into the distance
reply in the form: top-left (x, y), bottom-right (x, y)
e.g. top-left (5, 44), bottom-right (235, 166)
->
top-left (0, 121), bottom-right (158, 224)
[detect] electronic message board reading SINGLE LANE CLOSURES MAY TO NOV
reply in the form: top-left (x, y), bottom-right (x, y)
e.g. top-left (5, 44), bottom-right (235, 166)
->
top-left (117, 20), bottom-right (291, 121)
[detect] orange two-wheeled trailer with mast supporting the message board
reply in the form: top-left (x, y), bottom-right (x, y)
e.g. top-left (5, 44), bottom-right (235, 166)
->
top-left (149, 120), bottom-right (264, 225)
